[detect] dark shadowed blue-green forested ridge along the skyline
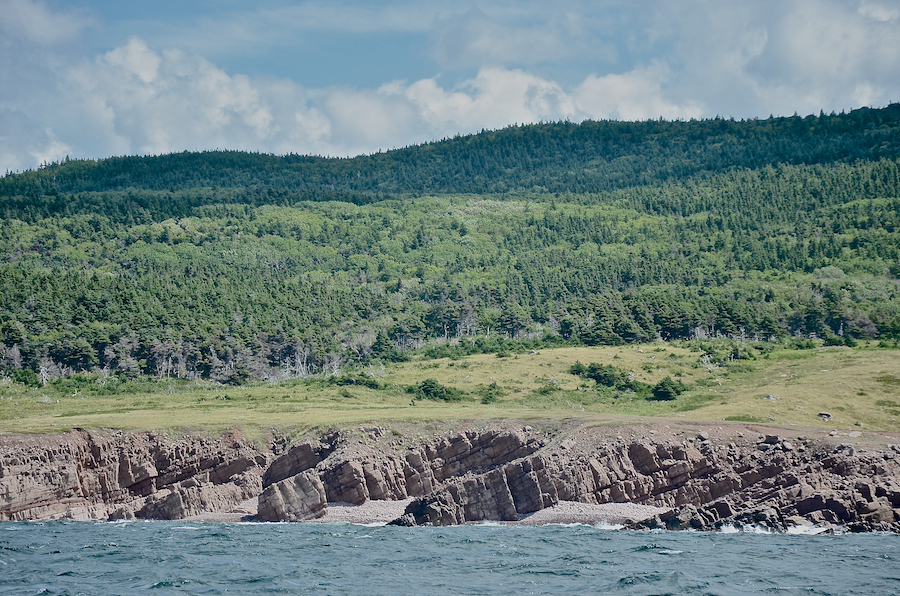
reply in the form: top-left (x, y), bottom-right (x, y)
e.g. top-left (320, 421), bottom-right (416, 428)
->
top-left (7, 104), bottom-right (900, 223)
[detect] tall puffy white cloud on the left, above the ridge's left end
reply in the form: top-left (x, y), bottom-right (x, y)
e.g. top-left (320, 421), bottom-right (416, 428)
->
top-left (68, 38), bottom-right (328, 153)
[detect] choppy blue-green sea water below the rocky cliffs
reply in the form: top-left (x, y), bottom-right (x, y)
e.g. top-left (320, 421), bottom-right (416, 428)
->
top-left (0, 522), bottom-right (900, 596)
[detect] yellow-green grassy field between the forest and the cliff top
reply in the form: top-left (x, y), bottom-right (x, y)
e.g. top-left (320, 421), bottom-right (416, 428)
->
top-left (0, 343), bottom-right (900, 436)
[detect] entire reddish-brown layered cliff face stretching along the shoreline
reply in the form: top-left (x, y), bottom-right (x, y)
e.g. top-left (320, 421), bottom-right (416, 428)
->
top-left (0, 426), bottom-right (900, 531)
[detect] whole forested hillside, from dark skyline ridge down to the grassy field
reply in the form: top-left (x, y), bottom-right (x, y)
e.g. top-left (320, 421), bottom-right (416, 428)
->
top-left (0, 104), bottom-right (900, 383)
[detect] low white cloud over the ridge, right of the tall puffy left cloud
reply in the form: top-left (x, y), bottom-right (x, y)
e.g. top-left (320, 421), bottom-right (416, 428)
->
top-left (322, 68), bottom-right (702, 154)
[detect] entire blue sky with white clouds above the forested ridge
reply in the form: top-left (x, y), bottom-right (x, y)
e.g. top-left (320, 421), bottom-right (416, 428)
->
top-left (0, 0), bottom-right (900, 175)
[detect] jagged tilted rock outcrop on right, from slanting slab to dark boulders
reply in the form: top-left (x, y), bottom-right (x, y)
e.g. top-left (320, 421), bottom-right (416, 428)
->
top-left (394, 431), bottom-right (900, 531)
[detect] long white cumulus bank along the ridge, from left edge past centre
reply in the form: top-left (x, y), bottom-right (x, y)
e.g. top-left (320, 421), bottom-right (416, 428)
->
top-left (0, 31), bottom-right (697, 169)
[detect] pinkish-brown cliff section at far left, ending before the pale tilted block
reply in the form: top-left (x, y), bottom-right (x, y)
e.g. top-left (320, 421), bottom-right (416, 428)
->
top-left (0, 431), bottom-right (269, 521)
